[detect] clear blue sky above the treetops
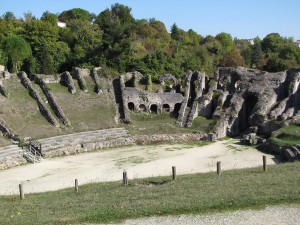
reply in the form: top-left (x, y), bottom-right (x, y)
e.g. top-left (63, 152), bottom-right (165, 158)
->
top-left (0, 0), bottom-right (300, 40)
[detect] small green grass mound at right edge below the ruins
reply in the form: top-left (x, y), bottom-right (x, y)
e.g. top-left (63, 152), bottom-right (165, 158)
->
top-left (270, 124), bottom-right (300, 146)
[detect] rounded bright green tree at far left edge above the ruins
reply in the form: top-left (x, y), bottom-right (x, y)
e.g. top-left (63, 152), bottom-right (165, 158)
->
top-left (2, 35), bottom-right (31, 72)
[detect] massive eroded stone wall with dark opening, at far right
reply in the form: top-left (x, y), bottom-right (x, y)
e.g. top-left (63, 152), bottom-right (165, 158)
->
top-left (211, 67), bottom-right (300, 138)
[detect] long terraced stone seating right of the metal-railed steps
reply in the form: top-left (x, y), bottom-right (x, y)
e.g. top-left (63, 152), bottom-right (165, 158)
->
top-left (38, 128), bottom-right (133, 157)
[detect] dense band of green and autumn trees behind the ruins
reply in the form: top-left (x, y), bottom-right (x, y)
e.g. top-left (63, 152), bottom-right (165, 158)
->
top-left (0, 3), bottom-right (300, 77)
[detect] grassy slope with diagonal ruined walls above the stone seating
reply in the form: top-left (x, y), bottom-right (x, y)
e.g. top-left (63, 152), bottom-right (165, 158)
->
top-left (0, 75), bottom-right (117, 141)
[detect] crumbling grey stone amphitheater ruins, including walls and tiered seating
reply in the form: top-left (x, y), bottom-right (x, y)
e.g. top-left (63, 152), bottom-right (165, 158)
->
top-left (0, 67), bottom-right (300, 169)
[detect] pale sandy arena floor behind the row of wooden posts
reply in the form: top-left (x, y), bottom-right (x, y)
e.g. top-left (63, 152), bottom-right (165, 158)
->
top-left (0, 140), bottom-right (275, 195)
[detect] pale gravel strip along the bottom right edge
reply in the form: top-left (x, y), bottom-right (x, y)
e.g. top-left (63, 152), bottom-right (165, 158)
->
top-left (94, 205), bottom-right (300, 225)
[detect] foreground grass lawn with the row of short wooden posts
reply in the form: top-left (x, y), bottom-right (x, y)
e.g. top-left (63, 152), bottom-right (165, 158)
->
top-left (0, 163), bottom-right (300, 225)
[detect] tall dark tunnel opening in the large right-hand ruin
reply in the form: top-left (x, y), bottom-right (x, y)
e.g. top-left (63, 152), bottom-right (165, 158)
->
top-left (239, 95), bottom-right (258, 132)
